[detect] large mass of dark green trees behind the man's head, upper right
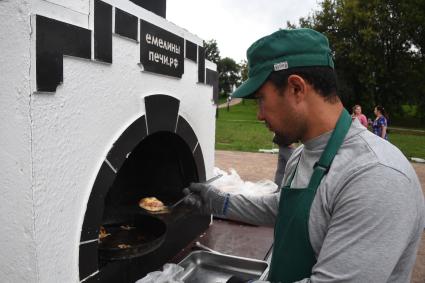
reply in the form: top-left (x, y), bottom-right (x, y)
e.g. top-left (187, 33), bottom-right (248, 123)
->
top-left (294, 0), bottom-right (425, 121)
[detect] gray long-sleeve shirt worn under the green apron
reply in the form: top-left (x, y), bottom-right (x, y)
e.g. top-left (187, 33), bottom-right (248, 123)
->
top-left (227, 120), bottom-right (425, 282)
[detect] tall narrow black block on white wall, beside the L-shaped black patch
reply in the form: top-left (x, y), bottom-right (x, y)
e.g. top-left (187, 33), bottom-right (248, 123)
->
top-left (94, 0), bottom-right (112, 63)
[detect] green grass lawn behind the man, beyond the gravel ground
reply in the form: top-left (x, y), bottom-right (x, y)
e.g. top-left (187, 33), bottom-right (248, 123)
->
top-left (215, 100), bottom-right (425, 159)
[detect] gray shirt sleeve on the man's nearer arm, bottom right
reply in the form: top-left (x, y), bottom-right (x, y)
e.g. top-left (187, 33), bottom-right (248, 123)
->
top-left (294, 165), bottom-right (422, 283)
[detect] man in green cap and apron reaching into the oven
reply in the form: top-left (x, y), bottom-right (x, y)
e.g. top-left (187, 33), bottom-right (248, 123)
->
top-left (188, 29), bottom-right (425, 282)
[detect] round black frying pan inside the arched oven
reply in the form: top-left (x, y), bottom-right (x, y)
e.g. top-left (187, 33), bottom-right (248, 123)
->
top-left (99, 214), bottom-right (167, 261)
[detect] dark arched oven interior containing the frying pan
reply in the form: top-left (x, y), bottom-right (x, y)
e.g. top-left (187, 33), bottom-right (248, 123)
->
top-left (98, 132), bottom-right (209, 282)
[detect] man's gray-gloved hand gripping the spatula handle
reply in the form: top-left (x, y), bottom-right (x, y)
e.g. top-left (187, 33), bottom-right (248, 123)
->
top-left (183, 183), bottom-right (229, 216)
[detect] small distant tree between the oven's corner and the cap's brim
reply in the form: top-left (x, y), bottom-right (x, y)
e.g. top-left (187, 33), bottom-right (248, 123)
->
top-left (217, 57), bottom-right (240, 95)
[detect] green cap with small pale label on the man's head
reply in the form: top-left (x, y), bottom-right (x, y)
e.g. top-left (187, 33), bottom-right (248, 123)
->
top-left (232, 28), bottom-right (334, 98)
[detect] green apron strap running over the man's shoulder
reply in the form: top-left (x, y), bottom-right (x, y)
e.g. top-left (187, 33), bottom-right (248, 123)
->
top-left (308, 108), bottom-right (352, 190)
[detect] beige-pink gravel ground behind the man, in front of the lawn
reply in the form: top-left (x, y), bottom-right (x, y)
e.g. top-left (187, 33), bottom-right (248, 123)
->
top-left (215, 150), bottom-right (425, 283)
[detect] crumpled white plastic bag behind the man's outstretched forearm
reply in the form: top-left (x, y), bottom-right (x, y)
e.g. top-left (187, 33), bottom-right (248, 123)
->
top-left (212, 167), bottom-right (278, 195)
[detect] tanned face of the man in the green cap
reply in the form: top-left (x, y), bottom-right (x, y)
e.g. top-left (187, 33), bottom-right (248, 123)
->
top-left (255, 82), bottom-right (302, 143)
